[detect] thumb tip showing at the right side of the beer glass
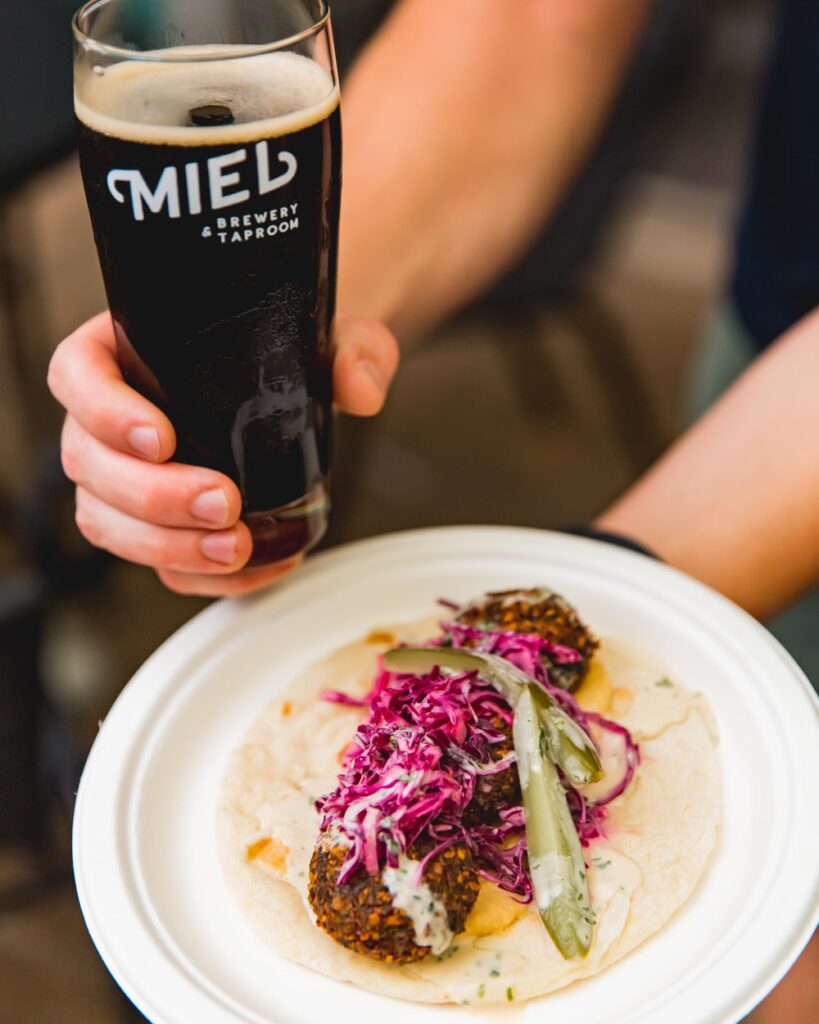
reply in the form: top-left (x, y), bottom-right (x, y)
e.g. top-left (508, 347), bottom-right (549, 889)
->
top-left (333, 317), bottom-right (398, 416)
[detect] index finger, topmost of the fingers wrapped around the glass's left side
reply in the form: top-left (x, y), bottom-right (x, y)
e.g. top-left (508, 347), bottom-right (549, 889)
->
top-left (48, 313), bottom-right (176, 462)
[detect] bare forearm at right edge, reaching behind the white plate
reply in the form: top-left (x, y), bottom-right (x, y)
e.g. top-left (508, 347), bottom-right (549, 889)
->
top-left (598, 311), bottom-right (819, 618)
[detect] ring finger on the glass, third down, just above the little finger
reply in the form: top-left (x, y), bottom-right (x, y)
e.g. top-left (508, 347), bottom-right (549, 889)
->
top-left (77, 487), bottom-right (253, 573)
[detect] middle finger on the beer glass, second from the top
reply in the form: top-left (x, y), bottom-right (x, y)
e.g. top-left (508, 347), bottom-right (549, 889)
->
top-left (62, 416), bottom-right (242, 529)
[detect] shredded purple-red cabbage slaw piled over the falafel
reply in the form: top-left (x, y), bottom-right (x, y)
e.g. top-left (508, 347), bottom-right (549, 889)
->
top-left (316, 623), bottom-right (640, 902)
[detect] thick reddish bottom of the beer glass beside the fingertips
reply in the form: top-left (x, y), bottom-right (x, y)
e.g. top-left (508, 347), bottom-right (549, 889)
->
top-left (242, 485), bottom-right (330, 568)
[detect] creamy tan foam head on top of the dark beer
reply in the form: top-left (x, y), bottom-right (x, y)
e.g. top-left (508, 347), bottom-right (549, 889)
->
top-left (75, 46), bottom-right (338, 145)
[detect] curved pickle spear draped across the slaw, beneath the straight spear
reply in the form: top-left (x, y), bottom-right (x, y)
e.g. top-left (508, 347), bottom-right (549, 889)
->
top-left (384, 647), bottom-right (603, 785)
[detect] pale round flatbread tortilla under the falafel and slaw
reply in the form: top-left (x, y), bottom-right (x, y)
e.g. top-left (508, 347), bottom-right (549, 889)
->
top-left (216, 618), bottom-right (720, 1005)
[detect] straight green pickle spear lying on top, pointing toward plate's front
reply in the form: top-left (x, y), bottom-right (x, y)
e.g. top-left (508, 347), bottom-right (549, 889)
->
top-left (512, 687), bottom-right (594, 959)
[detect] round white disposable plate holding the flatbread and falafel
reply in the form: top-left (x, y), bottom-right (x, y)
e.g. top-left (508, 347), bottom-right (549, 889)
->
top-left (74, 527), bottom-right (819, 1024)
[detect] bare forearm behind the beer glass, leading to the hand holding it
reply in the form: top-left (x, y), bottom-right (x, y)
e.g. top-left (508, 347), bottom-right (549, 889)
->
top-left (340, 0), bottom-right (649, 335)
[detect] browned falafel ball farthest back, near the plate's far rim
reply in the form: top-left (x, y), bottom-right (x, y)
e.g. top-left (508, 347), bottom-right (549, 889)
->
top-left (456, 587), bottom-right (599, 690)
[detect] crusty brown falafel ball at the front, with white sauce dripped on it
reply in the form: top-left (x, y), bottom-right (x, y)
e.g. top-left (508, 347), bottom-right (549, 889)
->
top-left (307, 840), bottom-right (480, 964)
